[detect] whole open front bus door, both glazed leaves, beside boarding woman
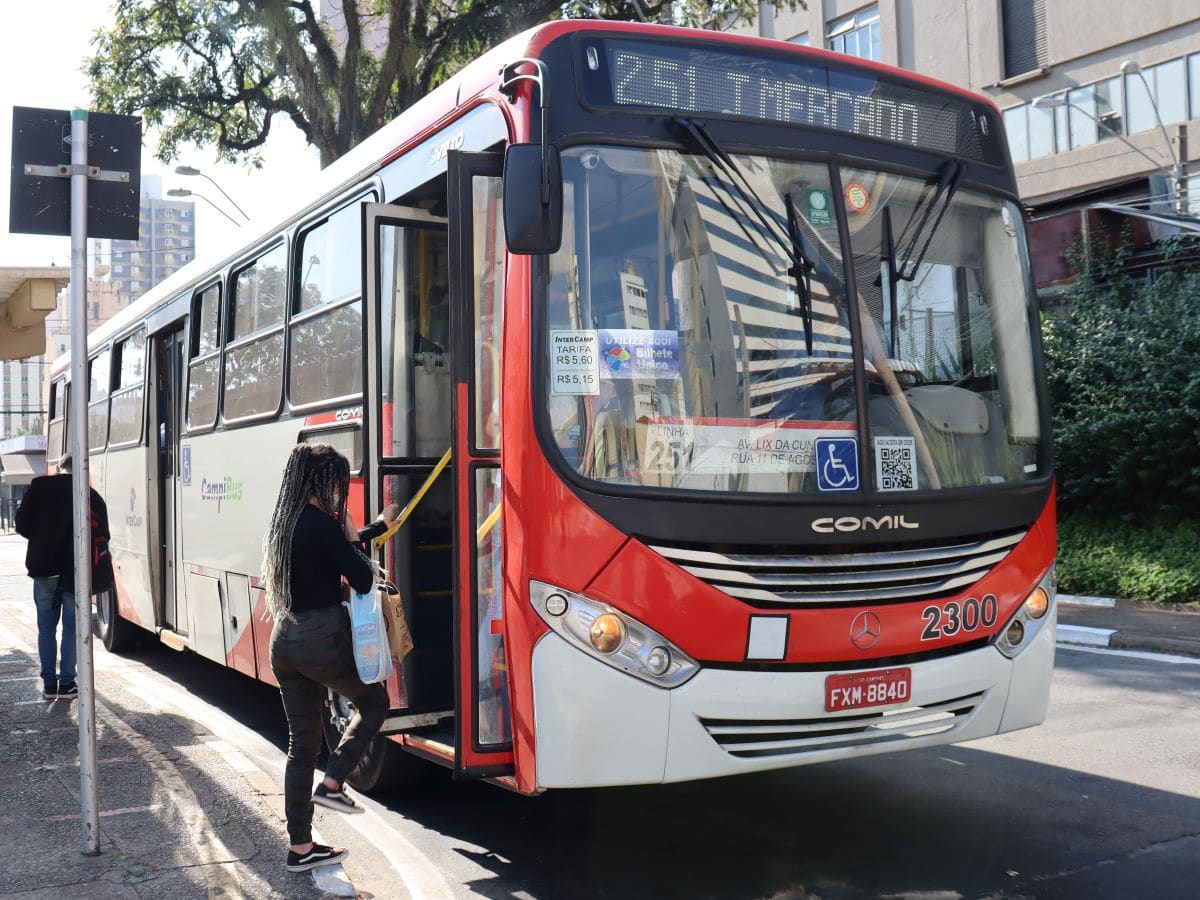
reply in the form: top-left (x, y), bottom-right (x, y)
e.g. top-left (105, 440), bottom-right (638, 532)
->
top-left (362, 154), bottom-right (512, 778)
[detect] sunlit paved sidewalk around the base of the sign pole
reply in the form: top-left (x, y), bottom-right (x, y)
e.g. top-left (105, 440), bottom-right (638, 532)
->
top-left (0, 535), bottom-right (354, 900)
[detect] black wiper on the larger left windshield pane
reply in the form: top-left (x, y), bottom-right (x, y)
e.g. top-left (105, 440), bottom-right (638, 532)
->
top-left (671, 115), bottom-right (832, 356)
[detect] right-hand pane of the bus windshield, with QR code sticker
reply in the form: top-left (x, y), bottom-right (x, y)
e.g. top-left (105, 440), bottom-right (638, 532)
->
top-left (844, 169), bottom-right (1044, 491)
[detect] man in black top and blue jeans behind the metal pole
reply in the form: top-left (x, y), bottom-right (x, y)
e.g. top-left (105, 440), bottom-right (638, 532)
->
top-left (16, 456), bottom-right (109, 700)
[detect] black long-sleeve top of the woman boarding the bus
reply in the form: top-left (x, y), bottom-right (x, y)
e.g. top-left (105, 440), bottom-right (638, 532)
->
top-left (292, 504), bottom-right (384, 613)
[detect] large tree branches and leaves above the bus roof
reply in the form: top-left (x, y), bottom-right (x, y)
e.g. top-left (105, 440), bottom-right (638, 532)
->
top-left (86, 0), bottom-right (803, 164)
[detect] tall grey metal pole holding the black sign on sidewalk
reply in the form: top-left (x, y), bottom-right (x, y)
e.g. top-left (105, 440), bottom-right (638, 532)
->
top-left (64, 109), bottom-right (100, 856)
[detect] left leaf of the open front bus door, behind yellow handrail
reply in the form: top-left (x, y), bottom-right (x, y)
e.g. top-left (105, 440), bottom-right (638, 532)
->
top-left (362, 204), bottom-right (454, 726)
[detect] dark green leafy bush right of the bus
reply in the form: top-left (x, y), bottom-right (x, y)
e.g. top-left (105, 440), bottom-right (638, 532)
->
top-left (1043, 240), bottom-right (1200, 521)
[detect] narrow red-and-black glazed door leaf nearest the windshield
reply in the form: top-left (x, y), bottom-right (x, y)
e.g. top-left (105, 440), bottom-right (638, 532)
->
top-left (449, 151), bottom-right (514, 776)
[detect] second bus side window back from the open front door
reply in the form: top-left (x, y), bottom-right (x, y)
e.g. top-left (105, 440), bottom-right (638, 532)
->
top-left (222, 244), bottom-right (288, 421)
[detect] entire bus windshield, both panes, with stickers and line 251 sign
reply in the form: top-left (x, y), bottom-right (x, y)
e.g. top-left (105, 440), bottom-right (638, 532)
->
top-left (542, 146), bottom-right (1045, 494)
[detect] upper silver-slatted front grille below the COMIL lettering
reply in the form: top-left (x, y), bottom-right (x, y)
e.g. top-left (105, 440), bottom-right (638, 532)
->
top-left (650, 529), bottom-right (1027, 606)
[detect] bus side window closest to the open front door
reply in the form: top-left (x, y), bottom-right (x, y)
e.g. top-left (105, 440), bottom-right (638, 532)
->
top-left (288, 197), bottom-right (365, 407)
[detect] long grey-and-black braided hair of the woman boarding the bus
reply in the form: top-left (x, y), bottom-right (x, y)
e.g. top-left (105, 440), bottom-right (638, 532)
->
top-left (263, 444), bottom-right (350, 620)
